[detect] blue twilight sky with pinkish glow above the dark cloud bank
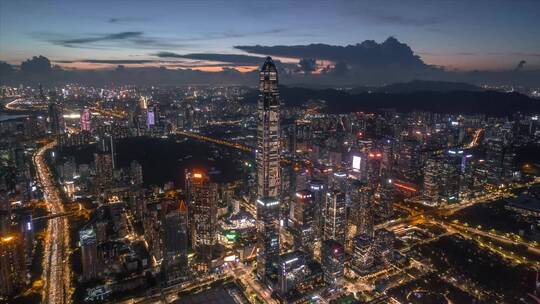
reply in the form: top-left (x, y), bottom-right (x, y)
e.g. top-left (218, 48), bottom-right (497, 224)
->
top-left (0, 0), bottom-right (540, 70)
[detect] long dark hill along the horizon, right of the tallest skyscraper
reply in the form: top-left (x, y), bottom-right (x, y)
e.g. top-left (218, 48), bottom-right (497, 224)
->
top-left (245, 86), bottom-right (540, 117)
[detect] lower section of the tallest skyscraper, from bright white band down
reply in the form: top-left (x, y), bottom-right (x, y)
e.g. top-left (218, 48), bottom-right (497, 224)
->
top-left (257, 197), bottom-right (280, 281)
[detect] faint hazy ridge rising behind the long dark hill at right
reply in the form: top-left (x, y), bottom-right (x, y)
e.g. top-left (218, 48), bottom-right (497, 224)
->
top-left (377, 80), bottom-right (482, 94)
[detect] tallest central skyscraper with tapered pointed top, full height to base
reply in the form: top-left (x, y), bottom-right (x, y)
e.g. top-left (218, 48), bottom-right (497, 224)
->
top-left (256, 57), bottom-right (280, 281)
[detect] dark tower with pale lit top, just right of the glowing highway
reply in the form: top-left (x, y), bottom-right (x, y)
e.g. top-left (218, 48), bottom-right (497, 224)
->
top-left (79, 225), bottom-right (99, 281)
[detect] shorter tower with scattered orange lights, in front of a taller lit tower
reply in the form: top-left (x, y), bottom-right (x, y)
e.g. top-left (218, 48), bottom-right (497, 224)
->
top-left (321, 240), bottom-right (345, 285)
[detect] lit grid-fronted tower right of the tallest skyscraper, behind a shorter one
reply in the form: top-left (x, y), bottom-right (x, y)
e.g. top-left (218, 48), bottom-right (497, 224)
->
top-left (324, 190), bottom-right (347, 244)
